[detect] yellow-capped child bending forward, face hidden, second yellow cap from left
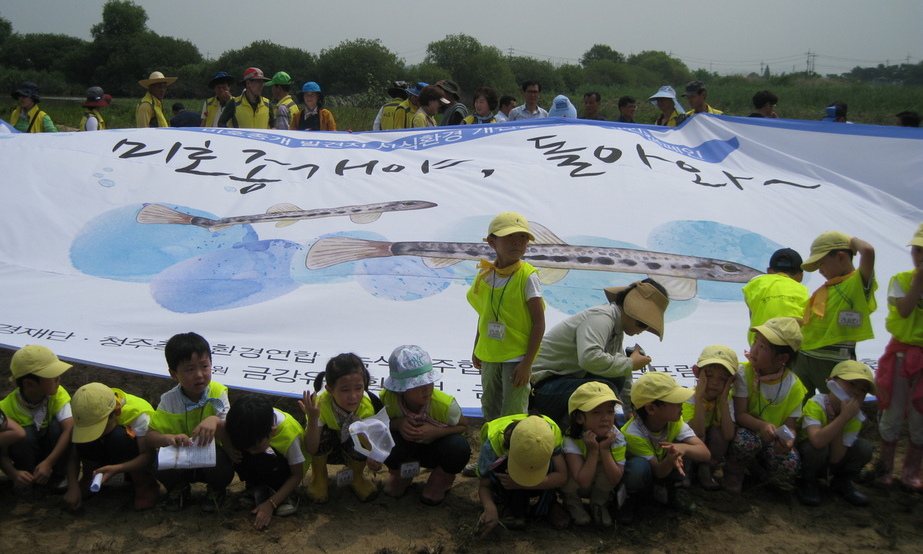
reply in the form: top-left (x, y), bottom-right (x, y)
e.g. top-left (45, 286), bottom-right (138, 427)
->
top-left (64, 383), bottom-right (160, 510)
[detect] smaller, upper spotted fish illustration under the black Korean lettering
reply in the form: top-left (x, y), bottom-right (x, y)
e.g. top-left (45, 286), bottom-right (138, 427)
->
top-left (137, 200), bottom-right (438, 231)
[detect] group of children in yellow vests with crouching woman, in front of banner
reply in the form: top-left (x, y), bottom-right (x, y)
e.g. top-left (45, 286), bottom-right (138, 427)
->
top-left (0, 207), bottom-right (923, 534)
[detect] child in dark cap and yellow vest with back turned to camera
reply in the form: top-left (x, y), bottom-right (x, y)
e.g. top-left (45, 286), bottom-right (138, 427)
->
top-left (734, 248), bottom-right (808, 344)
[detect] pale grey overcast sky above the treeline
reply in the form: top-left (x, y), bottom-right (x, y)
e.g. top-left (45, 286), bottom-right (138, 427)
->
top-left (0, 0), bottom-right (923, 74)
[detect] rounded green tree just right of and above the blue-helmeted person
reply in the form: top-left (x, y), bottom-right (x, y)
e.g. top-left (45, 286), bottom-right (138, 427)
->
top-left (316, 38), bottom-right (405, 94)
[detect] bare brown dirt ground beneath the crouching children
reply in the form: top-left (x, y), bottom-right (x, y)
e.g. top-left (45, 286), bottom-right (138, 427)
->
top-left (0, 350), bottom-right (923, 554)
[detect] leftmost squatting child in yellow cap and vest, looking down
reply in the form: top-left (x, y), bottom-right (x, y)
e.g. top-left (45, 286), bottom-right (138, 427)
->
top-left (0, 344), bottom-right (74, 493)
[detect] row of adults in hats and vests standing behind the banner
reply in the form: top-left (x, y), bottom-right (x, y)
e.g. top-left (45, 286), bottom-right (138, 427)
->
top-left (10, 71), bottom-right (920, 133)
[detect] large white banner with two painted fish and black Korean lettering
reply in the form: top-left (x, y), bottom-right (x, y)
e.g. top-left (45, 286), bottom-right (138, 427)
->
top-left (0, 116), bottom-right (923, 411)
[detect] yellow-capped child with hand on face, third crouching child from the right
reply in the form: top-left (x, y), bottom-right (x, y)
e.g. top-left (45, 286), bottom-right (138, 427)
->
top-left (683, 344), bottom-right (740, 490)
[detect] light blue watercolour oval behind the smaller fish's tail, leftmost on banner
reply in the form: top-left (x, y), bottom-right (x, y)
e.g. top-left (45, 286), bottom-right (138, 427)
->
top-left (70, 204), bottom-right (257, 282)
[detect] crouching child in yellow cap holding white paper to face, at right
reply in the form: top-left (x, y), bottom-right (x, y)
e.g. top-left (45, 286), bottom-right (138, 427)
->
top-left (797, 360), bottom-right (875, 506)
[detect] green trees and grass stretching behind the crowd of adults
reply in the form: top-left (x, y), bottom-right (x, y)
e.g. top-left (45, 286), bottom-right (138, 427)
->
top-left (0, 0), bottom-right (923, 131)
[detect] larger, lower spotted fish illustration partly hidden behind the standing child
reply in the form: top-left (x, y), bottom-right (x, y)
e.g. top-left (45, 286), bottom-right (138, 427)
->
top-left (305, 222), bottom-right (762, 300)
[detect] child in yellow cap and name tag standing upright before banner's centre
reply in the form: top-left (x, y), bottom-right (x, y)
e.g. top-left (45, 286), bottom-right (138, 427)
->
top-left (468, 212), bottom-right (545, 421)
